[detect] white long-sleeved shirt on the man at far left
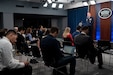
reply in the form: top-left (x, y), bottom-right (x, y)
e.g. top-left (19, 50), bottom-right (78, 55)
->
top-left (0, 37), bottom-right (25, 71)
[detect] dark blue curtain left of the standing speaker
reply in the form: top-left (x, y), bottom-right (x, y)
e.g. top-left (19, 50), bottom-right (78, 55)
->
top-left (68, 7), bottom-right (88, 33)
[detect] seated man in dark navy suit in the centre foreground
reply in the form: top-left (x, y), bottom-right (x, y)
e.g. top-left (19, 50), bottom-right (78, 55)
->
top-left (40, 27), bottom-right (76, 75)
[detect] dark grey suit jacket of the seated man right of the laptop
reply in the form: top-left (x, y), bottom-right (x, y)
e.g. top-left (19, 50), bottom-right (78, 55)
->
top-left (74, 33), bottom-right (97, 63)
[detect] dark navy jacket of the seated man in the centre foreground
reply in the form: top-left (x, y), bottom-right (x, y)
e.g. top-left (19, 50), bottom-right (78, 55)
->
top-left (40, 35), bottom-right (63, 65)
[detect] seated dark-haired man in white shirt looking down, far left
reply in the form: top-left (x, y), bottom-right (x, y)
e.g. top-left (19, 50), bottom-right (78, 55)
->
top-left (0, 30), bottom-right (32, 75)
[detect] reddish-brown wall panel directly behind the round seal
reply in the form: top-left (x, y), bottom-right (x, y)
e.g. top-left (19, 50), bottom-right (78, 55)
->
top-left (100, 2), bottom-right (111, 40)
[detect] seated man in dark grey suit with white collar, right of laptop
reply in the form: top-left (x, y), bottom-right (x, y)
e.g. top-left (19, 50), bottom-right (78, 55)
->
top-left (74, 26), bottom-right (103, 69)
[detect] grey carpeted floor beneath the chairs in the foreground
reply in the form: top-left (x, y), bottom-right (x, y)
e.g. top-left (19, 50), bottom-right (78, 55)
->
top-left (31, 54), bottom-right (113, 75)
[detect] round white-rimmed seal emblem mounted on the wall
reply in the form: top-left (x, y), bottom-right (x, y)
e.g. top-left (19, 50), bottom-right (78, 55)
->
top-left (98, 8), bottom-right (112, 19)
